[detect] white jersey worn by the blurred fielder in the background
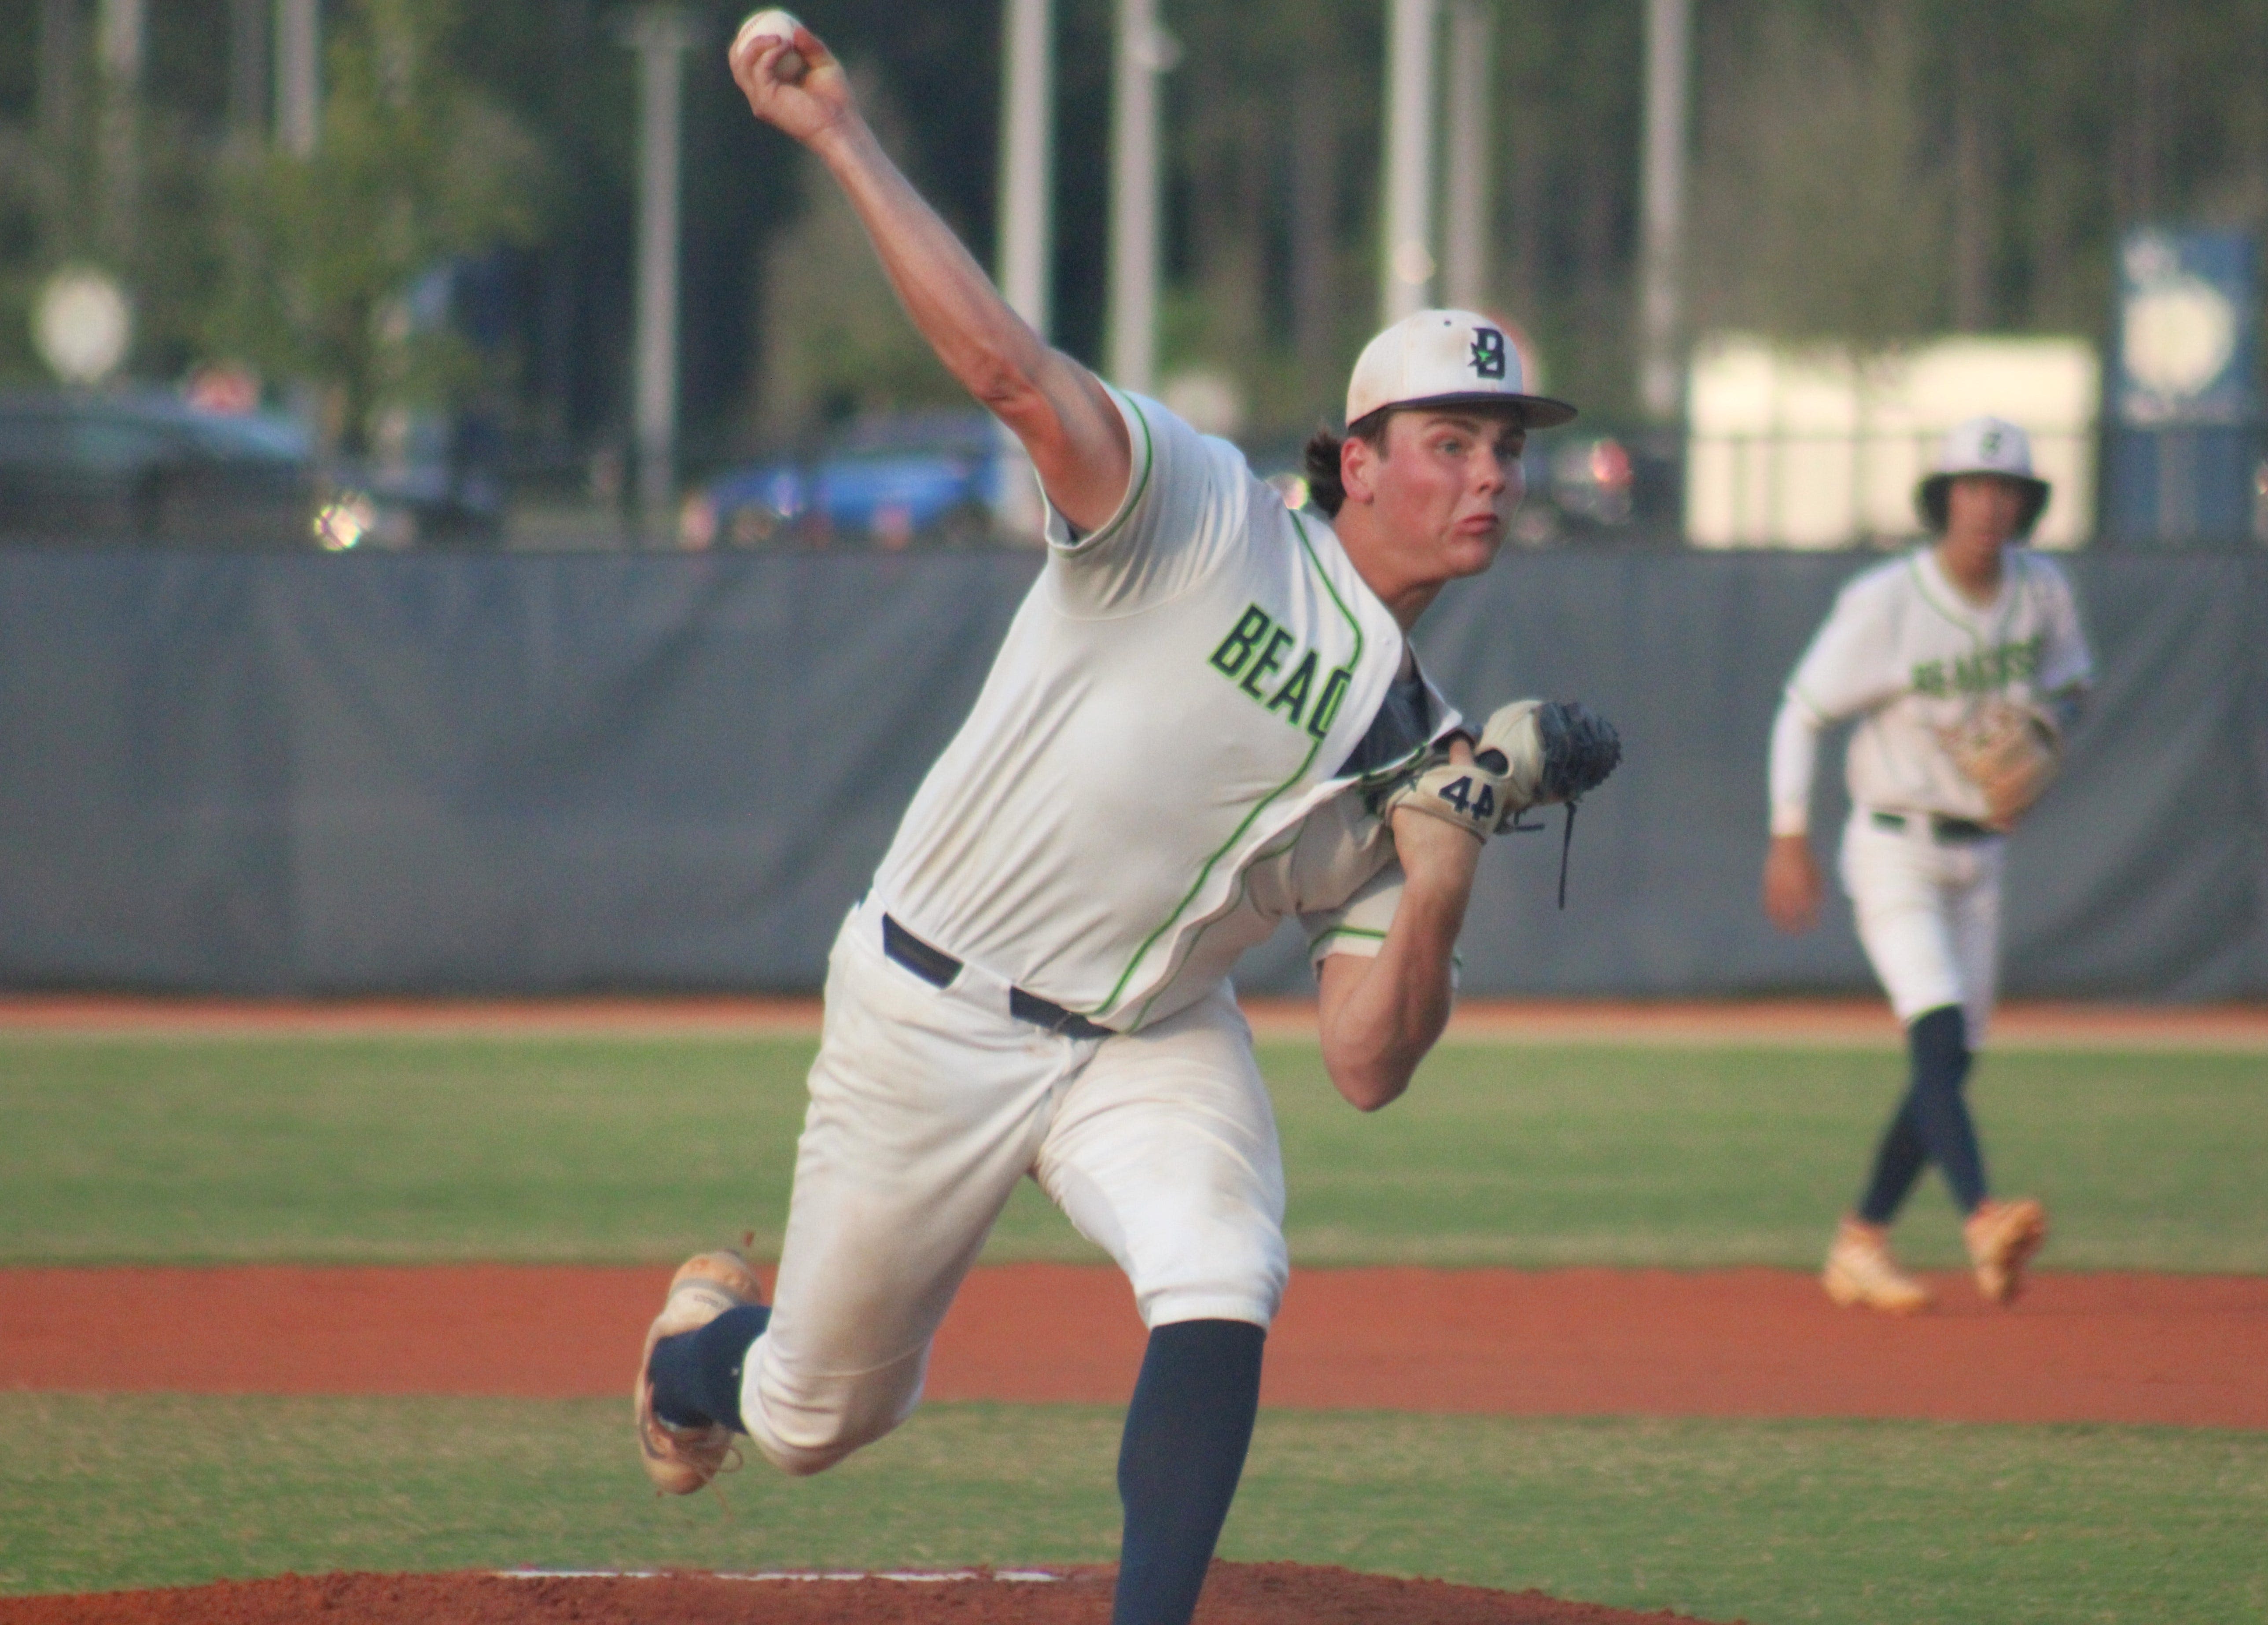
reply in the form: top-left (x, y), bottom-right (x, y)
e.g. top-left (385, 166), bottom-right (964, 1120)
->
top-left (1771, 547), bottom-right (2093, 835)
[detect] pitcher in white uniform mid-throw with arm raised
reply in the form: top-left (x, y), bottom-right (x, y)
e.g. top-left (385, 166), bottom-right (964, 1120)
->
top-left (635, 14), bottom-right (1617, 1625)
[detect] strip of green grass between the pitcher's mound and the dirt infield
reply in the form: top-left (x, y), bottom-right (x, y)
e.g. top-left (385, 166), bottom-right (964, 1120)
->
top-left (0, 1396), bottom-right (2268, 1625)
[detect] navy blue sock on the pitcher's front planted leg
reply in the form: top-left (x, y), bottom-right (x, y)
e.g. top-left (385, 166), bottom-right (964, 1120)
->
top-left (1111, 1321), bottom-right (1268, 1625)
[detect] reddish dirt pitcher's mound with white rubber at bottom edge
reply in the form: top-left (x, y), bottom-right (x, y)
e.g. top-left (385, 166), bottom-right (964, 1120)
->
top-left (0, 1564), bottom-right (1733, 1625)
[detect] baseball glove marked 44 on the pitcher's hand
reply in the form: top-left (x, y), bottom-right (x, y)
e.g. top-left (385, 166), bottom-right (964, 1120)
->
top-left (1379, 699), bottom-right (1622, 840)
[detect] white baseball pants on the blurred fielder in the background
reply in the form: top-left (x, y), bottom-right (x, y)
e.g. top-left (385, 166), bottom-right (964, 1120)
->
top-left (1841, 808), bottom-right (2007, 1049)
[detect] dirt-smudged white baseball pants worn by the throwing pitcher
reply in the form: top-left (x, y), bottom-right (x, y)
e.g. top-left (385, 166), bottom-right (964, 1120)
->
top-left (740, 899), bottom-right (1288, 1473)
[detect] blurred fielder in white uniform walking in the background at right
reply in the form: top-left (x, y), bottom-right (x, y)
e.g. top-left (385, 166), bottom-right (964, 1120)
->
top-left (1764, 418), bottom-right (2091, 1314)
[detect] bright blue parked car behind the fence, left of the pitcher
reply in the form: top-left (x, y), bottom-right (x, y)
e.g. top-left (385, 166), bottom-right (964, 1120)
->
top-left (678, 411), bottom-right (1012, 549)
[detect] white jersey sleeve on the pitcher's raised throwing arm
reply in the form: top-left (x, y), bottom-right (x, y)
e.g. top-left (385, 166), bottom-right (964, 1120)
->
top-left (1046, 388), bottom-right (1254, 615)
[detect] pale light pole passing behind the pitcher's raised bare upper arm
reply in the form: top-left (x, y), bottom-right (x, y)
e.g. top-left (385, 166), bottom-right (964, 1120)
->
top-left (994, 0), bottom-right (1055, 542)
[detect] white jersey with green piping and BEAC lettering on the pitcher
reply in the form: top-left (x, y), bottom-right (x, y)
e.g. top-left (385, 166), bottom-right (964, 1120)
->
top-left (876, 393), bottom-right (1456, 1030)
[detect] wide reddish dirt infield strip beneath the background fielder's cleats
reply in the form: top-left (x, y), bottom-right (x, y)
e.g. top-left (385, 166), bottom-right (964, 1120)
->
top-left (0, 1264), bottom-right (2268, 1428)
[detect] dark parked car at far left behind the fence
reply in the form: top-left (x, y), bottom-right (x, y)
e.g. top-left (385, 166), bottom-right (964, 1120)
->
top-left (0, 391), bottom-right (320, 547)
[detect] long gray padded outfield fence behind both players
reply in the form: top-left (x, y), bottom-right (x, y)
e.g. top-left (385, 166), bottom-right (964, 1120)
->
top-left (0, 552), bottom-right (2268, 999)
